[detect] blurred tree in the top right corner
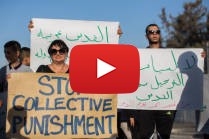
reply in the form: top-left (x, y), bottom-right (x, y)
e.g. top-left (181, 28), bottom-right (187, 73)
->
top-left (160, 0), bottom-right (209, 48)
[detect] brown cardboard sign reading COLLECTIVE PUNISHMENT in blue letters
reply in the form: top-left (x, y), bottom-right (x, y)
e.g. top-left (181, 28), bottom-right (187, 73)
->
top-left (6, 73), bottom-right (117, 139)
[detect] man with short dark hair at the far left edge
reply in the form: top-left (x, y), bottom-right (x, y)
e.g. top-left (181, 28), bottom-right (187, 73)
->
top-left (0, 40), bottom-right (32, 138)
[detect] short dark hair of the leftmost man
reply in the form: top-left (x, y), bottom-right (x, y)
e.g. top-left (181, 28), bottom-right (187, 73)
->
top-left (4, 40), bottom-right (21, 52)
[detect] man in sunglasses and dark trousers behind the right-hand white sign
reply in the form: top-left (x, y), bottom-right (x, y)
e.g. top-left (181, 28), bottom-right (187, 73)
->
top-left (131, 24), bottom-right (176, 139)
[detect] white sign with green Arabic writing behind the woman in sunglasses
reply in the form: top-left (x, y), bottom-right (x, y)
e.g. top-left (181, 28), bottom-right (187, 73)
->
top-left (31, 18), bottom-right (119, 71)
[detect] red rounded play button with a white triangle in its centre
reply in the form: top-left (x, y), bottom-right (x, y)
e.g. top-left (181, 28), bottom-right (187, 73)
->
top-left (69, 44), bottom-right (140, 94)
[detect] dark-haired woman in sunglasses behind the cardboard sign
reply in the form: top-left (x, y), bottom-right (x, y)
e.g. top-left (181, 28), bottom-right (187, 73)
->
top-left (36, 40), bottom-right (69, 73)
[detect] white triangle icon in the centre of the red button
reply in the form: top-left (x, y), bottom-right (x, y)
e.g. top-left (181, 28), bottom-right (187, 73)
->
top-left (97, 58), bottom-right (116, 78)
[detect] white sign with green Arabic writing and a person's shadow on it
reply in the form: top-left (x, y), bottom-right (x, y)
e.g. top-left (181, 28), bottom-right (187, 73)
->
top-left (118, 49), bottom-right (204, 110)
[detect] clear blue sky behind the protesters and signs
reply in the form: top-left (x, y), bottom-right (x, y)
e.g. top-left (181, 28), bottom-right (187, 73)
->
top-left (0, 0), bottom-right (209, 67)
